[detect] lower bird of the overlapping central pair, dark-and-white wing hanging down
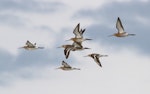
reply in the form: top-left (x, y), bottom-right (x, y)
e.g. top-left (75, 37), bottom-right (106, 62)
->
top-left (58, 42), bottom-right (90, 59)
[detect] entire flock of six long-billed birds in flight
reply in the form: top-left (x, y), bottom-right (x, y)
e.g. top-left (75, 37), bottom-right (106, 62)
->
top-left (21, 17), bottom-right (135, 70)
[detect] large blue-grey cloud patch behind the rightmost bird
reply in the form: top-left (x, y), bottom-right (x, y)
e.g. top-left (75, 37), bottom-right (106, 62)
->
top-left (74, 1), bottom-right (150, 53)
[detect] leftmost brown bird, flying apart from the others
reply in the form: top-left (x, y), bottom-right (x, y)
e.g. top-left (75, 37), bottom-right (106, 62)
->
top-left (20, 40), bottom-right (44, 50)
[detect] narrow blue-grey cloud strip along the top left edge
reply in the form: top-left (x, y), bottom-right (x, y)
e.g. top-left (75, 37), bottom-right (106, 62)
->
top-left (0, 0), bottom-right (64, 13)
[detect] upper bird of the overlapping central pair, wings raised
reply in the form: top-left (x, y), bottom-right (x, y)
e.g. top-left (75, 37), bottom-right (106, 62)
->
top-left (67, 23), bottom-right (92, 42)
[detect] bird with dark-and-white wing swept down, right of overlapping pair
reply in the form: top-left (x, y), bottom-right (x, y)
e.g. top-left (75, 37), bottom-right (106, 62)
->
top-left (85, 53), bottom-right (108, 67)
